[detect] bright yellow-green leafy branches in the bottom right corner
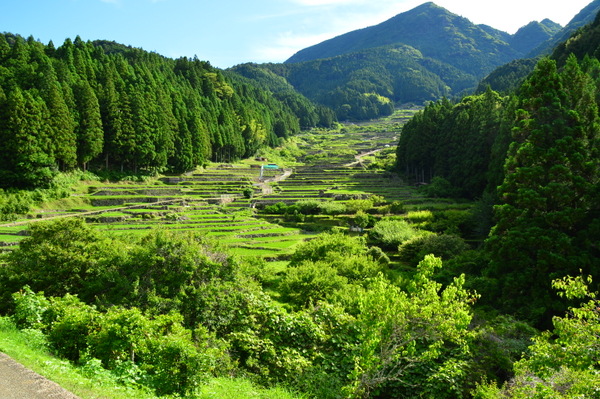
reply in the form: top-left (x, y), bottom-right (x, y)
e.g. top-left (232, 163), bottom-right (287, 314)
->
top-left (476, 276), bottom-right (600, 398)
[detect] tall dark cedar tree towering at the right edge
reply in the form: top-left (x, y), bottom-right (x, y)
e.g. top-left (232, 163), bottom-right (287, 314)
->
top-left (487, 57), bottom-right (599, 326)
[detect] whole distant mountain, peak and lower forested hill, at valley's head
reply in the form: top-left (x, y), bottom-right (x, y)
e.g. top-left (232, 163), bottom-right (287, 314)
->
top-left (234, 3), bottom-right (560, 120)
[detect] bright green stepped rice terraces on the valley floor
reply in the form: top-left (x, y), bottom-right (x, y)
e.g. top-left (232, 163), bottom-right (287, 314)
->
top-left (0, 109), bottom-right (426, 260)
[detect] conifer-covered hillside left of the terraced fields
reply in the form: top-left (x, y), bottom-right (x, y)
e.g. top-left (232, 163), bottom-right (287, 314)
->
top-left (0, 34), bottom-right (331, 187)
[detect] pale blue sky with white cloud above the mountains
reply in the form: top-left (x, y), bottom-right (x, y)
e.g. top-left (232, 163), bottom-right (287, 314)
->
top-left (0, 0), bottom-right (592, 68)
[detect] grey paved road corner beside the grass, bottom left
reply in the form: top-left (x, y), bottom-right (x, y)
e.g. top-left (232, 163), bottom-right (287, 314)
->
top-left (0, 352), bottom-right (79, 399)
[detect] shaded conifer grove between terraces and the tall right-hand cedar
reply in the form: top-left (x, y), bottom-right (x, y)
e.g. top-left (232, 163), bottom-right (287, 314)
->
top-left (396, 90), bottom-right (512, 198)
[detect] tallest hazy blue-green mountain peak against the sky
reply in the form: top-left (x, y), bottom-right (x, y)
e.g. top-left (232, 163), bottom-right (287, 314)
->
top-left (286, 2), bottom-right (553, 78)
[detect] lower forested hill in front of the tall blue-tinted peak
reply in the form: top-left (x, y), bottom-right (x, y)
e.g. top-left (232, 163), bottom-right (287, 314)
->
top-left (233, 45), bottom-right (477, 120)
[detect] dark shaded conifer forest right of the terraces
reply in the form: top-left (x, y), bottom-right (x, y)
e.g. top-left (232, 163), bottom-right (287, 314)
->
top-left (397, 38), bottom-right (600, 327)
